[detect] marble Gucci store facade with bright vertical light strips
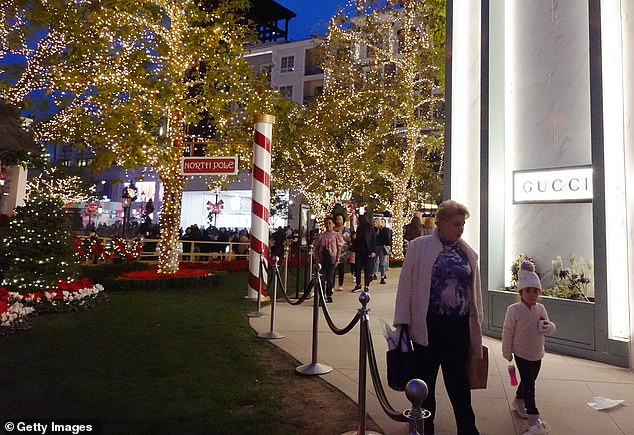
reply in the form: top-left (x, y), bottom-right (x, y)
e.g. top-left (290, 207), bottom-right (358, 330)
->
top-left (445, 0), bottom-right (634, 367)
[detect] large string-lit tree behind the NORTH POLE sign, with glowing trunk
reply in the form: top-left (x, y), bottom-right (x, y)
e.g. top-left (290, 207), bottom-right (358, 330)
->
top-left (0, 0), bottom-right (273, 273)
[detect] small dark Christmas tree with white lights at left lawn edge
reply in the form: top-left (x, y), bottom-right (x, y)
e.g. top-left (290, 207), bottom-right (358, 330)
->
top-left (4, 191), bottom-right (79, 291)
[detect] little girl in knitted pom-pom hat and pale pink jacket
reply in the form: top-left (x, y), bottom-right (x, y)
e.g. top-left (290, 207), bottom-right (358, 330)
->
top-left (502, 260), bottom-right (555, 435)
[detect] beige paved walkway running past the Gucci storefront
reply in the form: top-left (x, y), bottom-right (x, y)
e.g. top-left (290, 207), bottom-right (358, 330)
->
top-left (250, 269), bottom-right (634, 435)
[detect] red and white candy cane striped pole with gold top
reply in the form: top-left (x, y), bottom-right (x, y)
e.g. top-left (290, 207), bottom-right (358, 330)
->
top-left (247, 115), bottom-right (275, 300)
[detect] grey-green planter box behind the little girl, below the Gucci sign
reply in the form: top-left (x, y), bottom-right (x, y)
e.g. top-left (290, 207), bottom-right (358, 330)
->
top-left (483, 290), bottom-right (595, 350)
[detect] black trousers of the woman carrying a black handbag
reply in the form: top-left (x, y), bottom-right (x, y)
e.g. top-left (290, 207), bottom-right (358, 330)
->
top-left (414, 314), bottom-right (479, 435)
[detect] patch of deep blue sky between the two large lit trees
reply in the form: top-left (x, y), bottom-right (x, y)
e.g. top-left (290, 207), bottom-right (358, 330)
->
top-left (275, 0), bottom-right (347, 41)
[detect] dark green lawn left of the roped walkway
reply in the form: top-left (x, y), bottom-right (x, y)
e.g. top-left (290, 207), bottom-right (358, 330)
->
top-left (0, 273), bottom-right (294, 434)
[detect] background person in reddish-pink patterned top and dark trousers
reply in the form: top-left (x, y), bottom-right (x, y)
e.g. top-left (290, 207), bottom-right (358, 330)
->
top-left (313, 216), bottom-right (344, 302)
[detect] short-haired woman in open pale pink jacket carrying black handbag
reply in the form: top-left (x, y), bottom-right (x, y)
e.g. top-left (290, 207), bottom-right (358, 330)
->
top-left (394, 200), bottom-right (484, 435)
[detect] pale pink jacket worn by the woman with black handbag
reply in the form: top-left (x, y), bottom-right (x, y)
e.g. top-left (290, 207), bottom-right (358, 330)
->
top-left (394, 229), bottom-right (484, 358)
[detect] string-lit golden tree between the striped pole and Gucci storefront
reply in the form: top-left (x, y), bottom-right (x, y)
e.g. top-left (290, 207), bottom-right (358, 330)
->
top-left (272, 0), bottom-right (444, 256)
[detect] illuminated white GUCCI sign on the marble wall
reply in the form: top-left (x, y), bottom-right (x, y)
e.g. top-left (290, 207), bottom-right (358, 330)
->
top-left (513, 166), bottom-right (592, 203)
